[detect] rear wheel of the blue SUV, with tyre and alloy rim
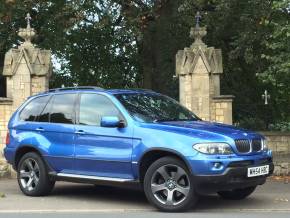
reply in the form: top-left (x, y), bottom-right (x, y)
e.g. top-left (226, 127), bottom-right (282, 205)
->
top-left (17, 152), bottom-right (55, 196)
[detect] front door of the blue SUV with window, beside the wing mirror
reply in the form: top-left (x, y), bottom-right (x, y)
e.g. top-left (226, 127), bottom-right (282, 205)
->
top-left (75, 93), bottom-right (133, 179)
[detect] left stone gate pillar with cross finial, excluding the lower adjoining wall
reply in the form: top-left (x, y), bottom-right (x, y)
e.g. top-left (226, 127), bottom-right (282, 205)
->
top-left (3, 13), bottom-right (52, 110)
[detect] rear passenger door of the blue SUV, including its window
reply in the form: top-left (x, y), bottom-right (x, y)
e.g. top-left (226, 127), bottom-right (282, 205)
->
top-left (35, 93), bottom-right (77, 173)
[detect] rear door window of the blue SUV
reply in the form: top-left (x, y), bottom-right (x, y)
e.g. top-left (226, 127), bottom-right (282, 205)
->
top-left (38, 94), bottom-right (76, 124)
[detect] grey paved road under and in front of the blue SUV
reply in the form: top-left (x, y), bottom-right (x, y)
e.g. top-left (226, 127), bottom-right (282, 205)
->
top-left (0, 180), bottom-right (290, 218)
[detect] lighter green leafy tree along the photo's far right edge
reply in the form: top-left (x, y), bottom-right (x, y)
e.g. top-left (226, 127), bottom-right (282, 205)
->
top-left (259, 0), bottom-right (290, 125)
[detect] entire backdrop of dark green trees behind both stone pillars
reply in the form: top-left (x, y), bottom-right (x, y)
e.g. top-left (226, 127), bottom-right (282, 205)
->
top-left (0, 0), bottom-right (290, 129)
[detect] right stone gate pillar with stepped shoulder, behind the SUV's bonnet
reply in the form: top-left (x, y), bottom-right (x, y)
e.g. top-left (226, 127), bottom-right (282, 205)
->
top-left (176, 21), bottom-right (233, 124)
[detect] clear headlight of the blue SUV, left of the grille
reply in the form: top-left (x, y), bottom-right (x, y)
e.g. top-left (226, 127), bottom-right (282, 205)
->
top-left (193, 142), bottom-right (233, 154)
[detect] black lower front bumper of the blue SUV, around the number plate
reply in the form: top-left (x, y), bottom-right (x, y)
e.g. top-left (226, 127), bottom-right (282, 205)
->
top-left (193, 162), bottom-right (274, 194)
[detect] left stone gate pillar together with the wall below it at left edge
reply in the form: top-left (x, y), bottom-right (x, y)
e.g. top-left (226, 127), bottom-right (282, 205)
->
top-left (0, 14), bottom-right (52, 178)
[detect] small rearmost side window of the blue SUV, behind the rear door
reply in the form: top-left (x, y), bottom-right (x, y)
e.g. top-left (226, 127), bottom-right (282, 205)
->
top-left (20, 96), bottom-right (50, 121)
